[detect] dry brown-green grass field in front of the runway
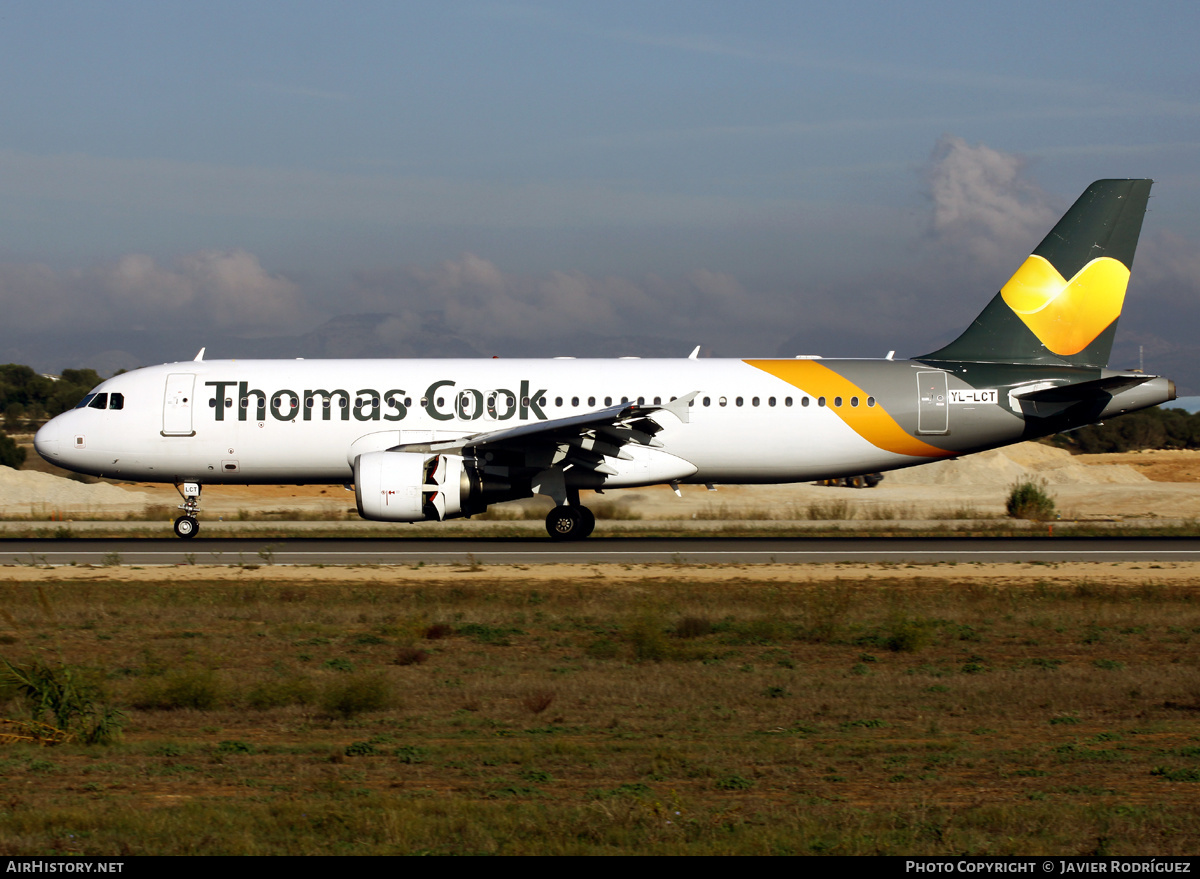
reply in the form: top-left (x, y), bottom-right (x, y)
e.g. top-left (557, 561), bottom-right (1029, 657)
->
top-left (0, 566), bottom-right (1200, 855)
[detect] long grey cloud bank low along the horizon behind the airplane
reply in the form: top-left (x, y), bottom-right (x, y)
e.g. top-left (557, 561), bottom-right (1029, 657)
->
top-left (9, 136), bottom-right (1200, 384)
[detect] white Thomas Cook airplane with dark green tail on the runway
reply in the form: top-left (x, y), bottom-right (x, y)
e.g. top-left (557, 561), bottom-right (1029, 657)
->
top-left (35, 180), bottom-right (1175, 540)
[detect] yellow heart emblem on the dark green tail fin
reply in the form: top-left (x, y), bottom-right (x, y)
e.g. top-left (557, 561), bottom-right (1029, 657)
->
top-left (1000, 255), bottom-right (1129, 357)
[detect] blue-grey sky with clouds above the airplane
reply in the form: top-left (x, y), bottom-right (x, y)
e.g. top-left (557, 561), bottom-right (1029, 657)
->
top-left (0, 0), bottom-right (1200, 384)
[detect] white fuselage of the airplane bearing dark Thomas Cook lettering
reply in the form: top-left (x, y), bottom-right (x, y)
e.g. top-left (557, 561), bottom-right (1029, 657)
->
top-left (36, 359), bottom-right (984, 486)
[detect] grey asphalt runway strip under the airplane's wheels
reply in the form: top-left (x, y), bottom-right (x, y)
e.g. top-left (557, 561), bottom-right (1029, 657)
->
top-left (0, 537), bottom-right (1200, 566)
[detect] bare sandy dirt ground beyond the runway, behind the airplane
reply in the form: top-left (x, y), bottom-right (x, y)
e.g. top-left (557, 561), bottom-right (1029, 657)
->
top-left (7, 443), bottom-right (1200, 521)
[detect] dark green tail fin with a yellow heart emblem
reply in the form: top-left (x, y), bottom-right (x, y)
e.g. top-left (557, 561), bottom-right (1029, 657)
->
top-left (916, 180), bottom-right (1153, 366)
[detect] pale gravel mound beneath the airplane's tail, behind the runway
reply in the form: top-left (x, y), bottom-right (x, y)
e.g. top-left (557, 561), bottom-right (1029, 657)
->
top-left (887, 443), bottom-right (1150, 485)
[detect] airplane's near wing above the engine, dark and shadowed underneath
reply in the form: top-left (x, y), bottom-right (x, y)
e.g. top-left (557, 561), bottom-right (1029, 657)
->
top-left (389, 390), bottom-right (700, 476)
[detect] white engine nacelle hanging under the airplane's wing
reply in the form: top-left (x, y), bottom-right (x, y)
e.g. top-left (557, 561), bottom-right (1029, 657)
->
top-left (354, 452), bottom-right (470, 522)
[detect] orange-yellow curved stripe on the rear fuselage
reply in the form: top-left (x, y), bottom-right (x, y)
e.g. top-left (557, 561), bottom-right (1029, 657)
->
top-left (744, 360), bottom-right (955, 458)
